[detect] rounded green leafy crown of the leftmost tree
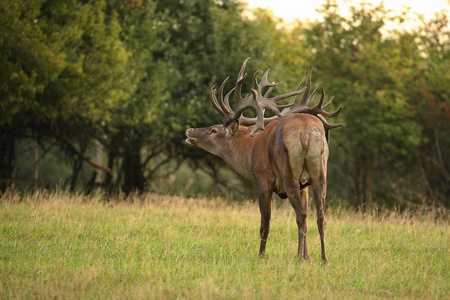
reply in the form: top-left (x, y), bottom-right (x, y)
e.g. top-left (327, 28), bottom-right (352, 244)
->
top-left (0, 1), bottom-right (127, 122)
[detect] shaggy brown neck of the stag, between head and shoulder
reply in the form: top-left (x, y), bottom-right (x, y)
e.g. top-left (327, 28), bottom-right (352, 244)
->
top-left (220, 130), bottom-right (255, 181)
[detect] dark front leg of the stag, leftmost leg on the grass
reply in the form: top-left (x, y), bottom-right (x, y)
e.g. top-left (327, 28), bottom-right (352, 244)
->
top-left (258, 187), bottom-right (272, 258)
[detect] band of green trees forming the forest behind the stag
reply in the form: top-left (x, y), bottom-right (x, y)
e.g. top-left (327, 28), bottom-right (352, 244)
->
top-left (0, 0), bottom-right (450, 208)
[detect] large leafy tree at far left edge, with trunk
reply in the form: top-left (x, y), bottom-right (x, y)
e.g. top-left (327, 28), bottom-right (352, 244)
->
top-left (0, 0), bottom-right (129, 187)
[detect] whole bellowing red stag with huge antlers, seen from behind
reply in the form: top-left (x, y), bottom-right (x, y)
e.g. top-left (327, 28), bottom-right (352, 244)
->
top-left (186, 58), bottom-right (342, 263)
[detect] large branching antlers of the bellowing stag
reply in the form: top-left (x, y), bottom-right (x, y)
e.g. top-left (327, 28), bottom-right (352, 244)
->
top-left (211, 58), bottom-right (342, 139)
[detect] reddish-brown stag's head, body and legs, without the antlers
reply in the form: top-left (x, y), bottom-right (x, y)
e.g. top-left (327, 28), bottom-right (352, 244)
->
top-left (187, 113), bottom-right (328, 260)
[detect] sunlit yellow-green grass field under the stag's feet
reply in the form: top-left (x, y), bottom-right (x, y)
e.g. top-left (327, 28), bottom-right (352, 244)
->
top-left (0, 193), bottom-right (450, 299)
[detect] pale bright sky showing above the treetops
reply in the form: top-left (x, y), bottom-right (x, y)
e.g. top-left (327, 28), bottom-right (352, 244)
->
top-left (242, 0), bottom-right (450, 22)
